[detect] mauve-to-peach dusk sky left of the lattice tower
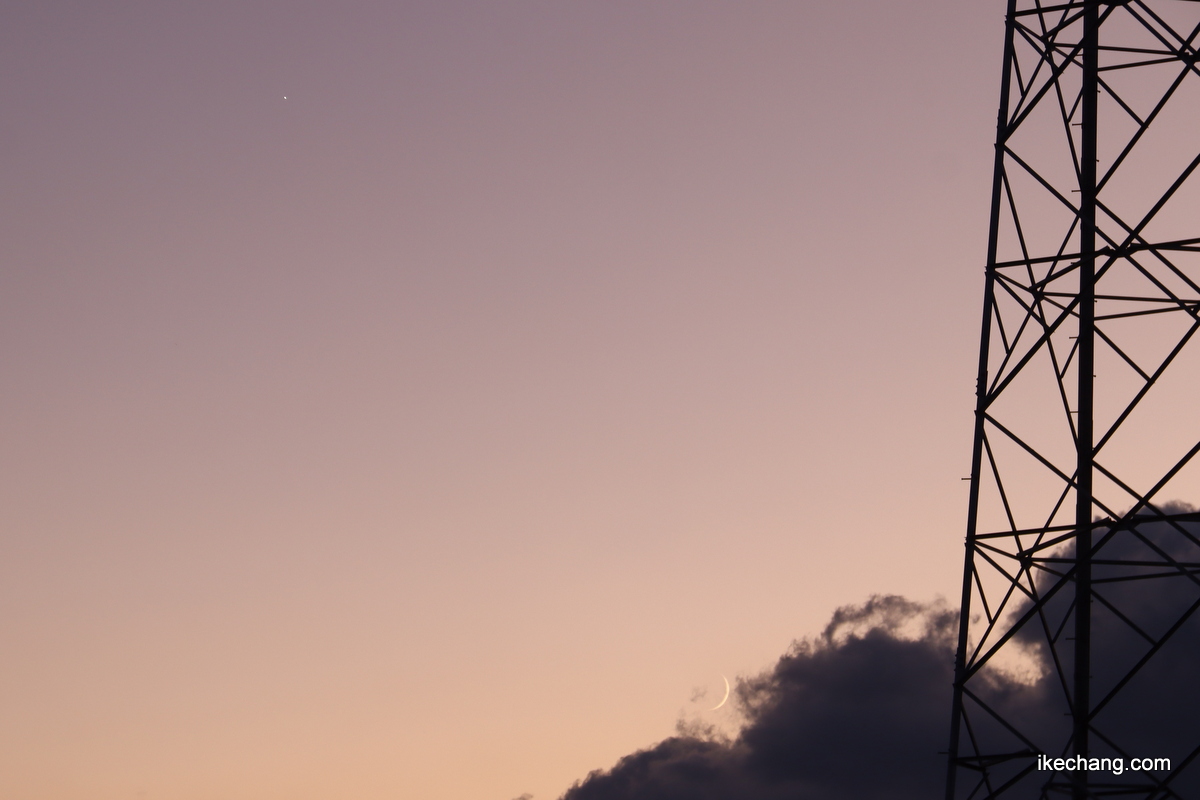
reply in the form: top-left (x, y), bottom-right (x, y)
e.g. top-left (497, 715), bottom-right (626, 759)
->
top-left (0, 0), bottom-right (1004, 800)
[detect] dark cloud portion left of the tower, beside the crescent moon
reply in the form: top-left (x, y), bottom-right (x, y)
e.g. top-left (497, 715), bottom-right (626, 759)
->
top-left (563, 597), bottom-right (955, 800)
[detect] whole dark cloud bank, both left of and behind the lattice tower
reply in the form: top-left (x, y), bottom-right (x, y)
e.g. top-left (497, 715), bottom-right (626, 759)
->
top-left (562, 506), bottom-right (1200, 800)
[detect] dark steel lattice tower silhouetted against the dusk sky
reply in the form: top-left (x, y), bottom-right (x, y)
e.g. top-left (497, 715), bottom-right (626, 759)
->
top-left (947, 0), bottom-right (1200, 800)
